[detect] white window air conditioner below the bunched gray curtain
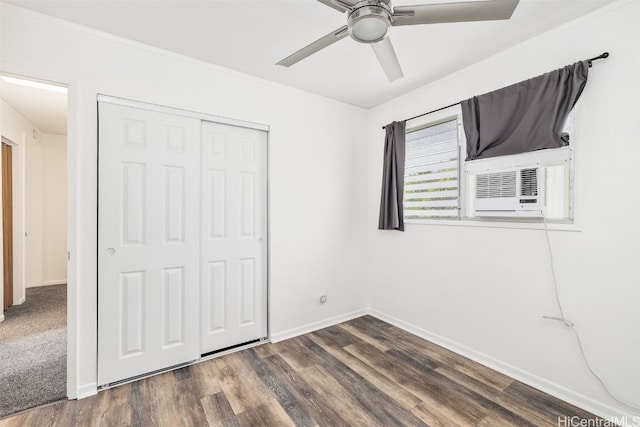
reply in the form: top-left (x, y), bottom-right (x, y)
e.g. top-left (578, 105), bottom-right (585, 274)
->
top-left (473, 166), bottom-right (544, 218)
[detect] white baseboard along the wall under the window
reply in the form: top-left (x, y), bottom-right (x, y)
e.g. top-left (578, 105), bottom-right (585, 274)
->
top-left (368, 309), bottom-right (640, 420)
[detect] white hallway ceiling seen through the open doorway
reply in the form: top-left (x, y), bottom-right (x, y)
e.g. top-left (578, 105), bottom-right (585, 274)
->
top-left (0, 79), bottom-right (67, 135)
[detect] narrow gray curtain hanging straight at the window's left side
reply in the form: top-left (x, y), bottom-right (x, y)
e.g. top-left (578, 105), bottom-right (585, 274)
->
top-left (378, 121), bottom-right (406, 231)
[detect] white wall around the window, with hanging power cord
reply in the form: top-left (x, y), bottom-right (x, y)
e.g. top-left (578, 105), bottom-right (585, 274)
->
top-left (367, 1), bottom-right (640, 422)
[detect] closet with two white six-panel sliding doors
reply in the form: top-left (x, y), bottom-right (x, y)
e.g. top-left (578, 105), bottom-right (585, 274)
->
top-left (98, 95), bottom-right (268, 386)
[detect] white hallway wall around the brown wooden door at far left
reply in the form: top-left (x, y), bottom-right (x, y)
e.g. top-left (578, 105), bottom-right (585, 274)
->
top-left (0, 99), bottom-right (30, 304)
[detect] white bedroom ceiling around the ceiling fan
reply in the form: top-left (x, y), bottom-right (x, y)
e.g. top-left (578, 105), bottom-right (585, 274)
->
top-left (2, 0), bottom-right (613, 108)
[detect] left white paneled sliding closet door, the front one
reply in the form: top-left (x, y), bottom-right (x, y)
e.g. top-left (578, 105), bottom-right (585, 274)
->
top-left (98, 102), bottom-right (201, 385)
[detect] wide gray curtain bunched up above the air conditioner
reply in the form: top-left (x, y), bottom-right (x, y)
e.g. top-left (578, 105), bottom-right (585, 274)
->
top-left (460, 61), bottom-right (589, 160)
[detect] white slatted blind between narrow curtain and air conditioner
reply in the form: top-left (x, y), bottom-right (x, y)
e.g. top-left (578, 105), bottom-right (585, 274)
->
top-left (404, 118), bottom-right (460, 219)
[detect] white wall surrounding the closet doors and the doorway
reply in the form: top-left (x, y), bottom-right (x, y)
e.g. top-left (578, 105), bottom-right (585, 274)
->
top-left (0, 3), bottom-right (366, 397)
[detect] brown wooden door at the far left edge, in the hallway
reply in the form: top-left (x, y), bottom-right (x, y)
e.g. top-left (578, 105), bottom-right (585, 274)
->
top-left (2, 142), bottom-right (13, 309)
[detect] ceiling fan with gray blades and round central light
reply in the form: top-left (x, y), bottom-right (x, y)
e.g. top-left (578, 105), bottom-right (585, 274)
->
top-left (277, 0), bottom-right (519, 82)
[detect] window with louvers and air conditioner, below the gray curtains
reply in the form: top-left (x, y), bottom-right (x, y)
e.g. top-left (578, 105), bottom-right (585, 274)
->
top-left (404, 108), bottom-right (574, 223)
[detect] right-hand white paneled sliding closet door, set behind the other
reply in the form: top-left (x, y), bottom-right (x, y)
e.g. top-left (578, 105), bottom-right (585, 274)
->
top-left (201, 122), bottom-right (267, 354)
